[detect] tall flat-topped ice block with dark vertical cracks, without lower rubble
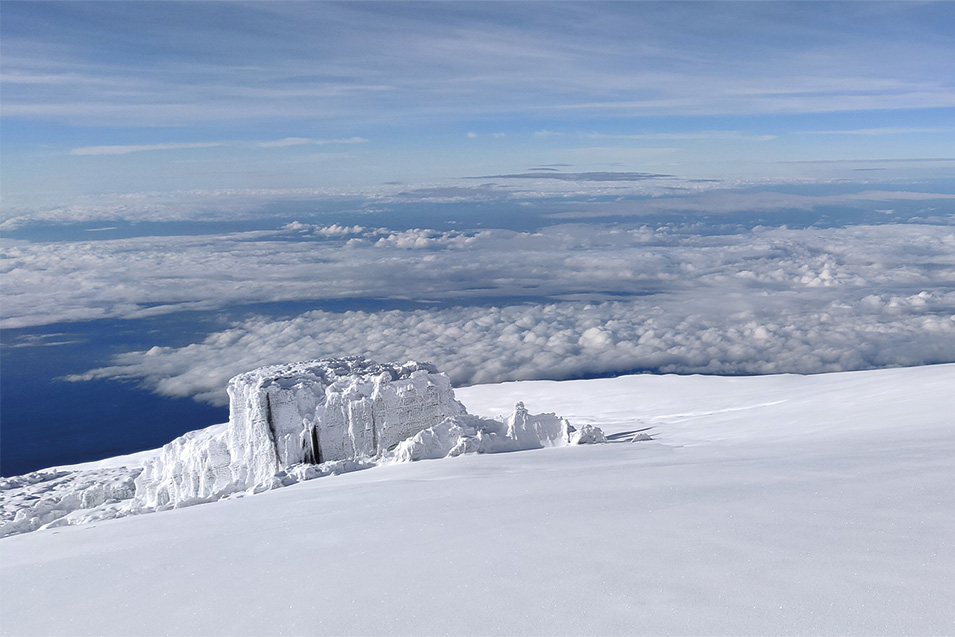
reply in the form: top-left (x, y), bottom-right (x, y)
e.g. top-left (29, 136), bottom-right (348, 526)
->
top-left (221, 357), bottom-right (465, 488)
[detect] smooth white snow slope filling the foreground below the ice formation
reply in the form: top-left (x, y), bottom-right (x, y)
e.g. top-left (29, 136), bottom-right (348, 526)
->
top-left (0, 365), bottom-right (955, 635)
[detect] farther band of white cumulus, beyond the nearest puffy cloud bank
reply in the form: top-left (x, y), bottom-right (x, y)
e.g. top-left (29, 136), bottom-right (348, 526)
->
top-left (0, 223), bottom-right (955, 328)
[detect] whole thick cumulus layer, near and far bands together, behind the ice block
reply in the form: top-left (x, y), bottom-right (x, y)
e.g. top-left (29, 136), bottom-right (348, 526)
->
top-left (14, 223), bottom-right (955, 402)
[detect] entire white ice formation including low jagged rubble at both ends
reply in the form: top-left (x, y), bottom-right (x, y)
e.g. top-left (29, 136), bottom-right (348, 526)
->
top-left (0, 357), bottom-right (604, 537)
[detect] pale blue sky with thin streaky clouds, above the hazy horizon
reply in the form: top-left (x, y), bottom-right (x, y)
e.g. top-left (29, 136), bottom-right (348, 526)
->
top-left (2, 2), bottom-right (955, 206)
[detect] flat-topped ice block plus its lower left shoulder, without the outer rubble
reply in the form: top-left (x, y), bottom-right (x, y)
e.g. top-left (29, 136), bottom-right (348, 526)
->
top-left (136, 357), bottom-right (465, 508)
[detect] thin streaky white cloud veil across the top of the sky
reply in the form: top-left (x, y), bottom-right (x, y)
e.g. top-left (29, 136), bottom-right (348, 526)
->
top-left (4, 3), bottom-right (955, 131)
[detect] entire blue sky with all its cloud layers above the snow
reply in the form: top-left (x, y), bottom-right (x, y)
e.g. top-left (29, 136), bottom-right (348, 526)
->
top-left (0, 1), bottom-right (955, 467)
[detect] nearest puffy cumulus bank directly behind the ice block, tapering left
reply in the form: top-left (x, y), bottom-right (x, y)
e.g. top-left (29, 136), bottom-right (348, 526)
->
top-left (70, 291), bottom-right (955, 404)
